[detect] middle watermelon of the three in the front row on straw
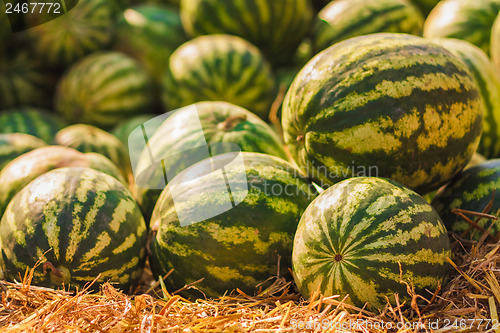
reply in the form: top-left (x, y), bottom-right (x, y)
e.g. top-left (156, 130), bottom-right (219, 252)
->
top-left (150, 152), bottom-right (315, 297)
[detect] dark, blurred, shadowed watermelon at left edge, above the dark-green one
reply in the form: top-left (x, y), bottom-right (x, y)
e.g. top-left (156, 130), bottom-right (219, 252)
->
top-left (0, 50), bottom-right (56, 110)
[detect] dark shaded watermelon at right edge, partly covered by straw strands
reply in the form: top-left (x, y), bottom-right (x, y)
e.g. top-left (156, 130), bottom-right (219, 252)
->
top-left (432, 159), bottom-right (500, 240)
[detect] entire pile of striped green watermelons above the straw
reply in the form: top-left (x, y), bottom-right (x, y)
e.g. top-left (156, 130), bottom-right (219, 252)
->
top-left (0, 0), bottom-right (500, 308)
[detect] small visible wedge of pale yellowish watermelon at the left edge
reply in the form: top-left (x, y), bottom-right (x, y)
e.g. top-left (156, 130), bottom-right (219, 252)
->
top-left (0, 133), bottom-right (47, 171)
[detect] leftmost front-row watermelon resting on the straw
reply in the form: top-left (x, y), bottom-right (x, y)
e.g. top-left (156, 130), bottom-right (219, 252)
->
top-left (0, 168), bottom-right (147, 289)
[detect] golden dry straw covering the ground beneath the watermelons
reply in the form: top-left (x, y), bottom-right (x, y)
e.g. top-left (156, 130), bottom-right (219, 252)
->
top-left (0, 207), bottom-right (500, 333)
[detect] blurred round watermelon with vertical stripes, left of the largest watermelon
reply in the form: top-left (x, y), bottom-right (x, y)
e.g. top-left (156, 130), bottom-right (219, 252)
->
top-left (163, 35), bottom-right (276, 118)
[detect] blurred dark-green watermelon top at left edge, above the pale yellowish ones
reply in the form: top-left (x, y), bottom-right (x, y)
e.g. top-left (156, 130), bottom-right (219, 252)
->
top-left (0, 107), bottom-right (66, 143)
